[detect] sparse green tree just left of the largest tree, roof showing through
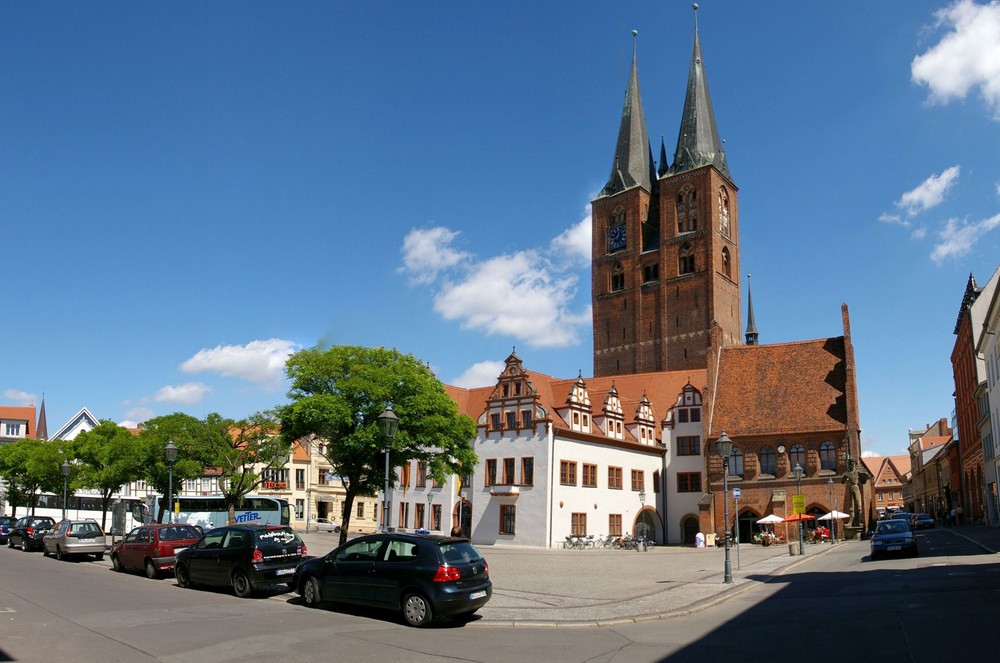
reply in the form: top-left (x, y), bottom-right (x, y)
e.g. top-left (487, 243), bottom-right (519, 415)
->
top-left (204, 412), bottom-right (291, 523)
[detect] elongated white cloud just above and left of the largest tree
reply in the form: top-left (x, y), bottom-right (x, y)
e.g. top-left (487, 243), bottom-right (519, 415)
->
top-left (180, 338), bottom-right (301, 388)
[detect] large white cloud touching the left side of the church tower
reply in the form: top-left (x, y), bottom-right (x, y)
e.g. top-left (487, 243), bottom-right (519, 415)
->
top-left (400, 219), bottom-right (591, 350)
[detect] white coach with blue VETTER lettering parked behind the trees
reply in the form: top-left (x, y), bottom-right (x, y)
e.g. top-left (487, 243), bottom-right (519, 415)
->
top-left (150, 495), bottom-right (291, 530)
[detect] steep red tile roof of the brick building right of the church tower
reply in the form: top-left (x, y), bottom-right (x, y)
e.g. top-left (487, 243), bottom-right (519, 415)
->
top-left (708, 336), bottom-right (848, 439)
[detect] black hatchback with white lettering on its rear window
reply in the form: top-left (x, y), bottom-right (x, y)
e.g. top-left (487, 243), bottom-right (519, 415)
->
top-left (174, 525), bottom-right (306, 598)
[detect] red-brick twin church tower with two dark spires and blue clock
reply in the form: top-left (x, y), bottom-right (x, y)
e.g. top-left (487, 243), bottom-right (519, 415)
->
top-left (591, 9), bottom-right (742, 377)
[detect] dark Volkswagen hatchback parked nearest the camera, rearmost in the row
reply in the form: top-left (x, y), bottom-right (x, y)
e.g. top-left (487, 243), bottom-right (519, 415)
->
top-left (292, 533), bottom-right (493, 626)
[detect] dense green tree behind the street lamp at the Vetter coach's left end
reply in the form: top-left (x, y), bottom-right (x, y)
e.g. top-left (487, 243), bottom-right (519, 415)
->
top-left (139, 412), bottom-right (211, 522)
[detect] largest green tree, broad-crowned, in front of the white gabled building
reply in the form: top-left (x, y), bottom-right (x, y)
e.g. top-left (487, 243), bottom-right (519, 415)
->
top-left (277, 345), bottom-right (477, 543)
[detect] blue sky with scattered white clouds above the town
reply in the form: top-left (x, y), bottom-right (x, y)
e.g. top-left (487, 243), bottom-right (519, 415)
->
top-left (0, 0), bottom-right (1000, 462)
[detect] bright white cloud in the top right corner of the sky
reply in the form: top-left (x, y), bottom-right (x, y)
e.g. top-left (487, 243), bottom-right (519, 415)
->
top-left (910, 0), bottom-right (1000, 120)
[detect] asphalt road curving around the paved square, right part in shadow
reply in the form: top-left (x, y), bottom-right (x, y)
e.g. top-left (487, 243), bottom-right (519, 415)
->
top-left (0, 530), bottom-right (1000, 663)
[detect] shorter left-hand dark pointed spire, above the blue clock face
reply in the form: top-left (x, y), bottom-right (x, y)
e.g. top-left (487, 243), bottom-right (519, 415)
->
top-left (601, 30), bottom-right (654, 196)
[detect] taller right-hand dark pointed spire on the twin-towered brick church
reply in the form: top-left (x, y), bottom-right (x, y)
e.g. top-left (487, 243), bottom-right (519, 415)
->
top-left (670, 5), bottom-right (733, 181)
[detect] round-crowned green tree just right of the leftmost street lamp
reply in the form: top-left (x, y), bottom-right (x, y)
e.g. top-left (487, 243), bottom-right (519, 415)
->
top-left (72, 421), bottom-right (145, 529)
